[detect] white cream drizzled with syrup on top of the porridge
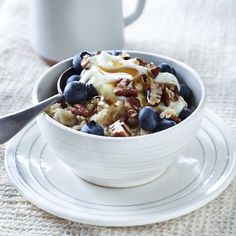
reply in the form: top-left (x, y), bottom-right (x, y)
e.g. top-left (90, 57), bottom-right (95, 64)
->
top-left (80, 52), bottom-right (187, 115)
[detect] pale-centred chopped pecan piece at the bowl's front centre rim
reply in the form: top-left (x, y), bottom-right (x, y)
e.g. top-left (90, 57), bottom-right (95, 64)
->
top-left (109, 120), bottom-right (131, 137)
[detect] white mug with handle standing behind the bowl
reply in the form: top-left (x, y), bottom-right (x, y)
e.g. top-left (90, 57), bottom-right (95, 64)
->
top-left (31, 0), bottom-right (145, 62)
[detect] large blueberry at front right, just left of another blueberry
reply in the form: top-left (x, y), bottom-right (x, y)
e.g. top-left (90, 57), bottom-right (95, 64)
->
top-left (138, 106), bottom-right (158, 131)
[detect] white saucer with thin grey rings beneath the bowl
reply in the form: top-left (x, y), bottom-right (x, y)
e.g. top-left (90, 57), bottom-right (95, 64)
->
top-left (5, 110), bottom-right (236, 226)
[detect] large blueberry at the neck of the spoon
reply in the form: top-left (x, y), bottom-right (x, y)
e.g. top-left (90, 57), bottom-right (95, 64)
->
top-left (64, 81), bottom-right (88, 105)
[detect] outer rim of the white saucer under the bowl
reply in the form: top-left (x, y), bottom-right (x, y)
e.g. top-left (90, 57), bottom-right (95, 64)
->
top-left (5, 109), bottom-right (236, 227)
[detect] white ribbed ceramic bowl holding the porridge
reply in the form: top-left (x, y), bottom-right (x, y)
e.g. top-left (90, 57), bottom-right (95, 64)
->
top-left (33, 51), bottom-right (206, 187)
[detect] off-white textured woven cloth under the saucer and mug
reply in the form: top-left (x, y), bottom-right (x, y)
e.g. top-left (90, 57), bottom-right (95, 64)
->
top-left (0, 0), bottom-right (236, 236)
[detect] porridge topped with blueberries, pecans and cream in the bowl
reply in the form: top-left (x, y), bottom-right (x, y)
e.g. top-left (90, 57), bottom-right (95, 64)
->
top-left (47, 51), bottom-right (193, 137)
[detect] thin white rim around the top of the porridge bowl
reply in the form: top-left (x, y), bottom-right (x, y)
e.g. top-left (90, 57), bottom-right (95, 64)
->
top-left (32, 49), bottom-right (206, 141)
